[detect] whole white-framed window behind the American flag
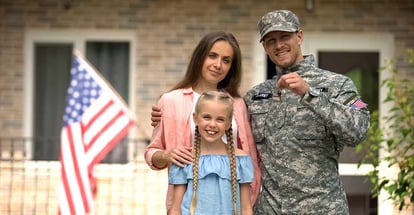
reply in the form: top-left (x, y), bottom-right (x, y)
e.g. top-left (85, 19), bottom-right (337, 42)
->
top-left (25, 29), bottom-right (133, 163)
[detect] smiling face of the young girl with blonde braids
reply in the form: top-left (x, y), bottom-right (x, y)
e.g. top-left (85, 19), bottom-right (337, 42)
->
top-left (194, 101), bottom-right (231, 143)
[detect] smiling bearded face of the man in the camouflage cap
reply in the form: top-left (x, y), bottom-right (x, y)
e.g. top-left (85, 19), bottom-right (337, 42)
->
top-left (263, 30), bottom-right (303, 68)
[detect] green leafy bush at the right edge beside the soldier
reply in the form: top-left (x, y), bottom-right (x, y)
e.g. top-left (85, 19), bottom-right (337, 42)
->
top-left (357, 49), bottom-right (414, 211)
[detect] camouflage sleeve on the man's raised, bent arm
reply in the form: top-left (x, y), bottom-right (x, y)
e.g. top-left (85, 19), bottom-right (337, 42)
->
top-left (301, 78), bottom-right (370, 148)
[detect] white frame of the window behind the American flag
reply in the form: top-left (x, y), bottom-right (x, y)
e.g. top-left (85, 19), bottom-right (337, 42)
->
top-left (23, 29), bottom-right (136, 159)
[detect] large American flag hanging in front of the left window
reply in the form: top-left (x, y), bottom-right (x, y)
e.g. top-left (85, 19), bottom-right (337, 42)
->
top-left (59, 52), bottom-right (134, 215)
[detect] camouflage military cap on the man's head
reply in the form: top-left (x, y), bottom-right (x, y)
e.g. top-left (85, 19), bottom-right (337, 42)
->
top-left (257, 10), bottom-right (300, 42)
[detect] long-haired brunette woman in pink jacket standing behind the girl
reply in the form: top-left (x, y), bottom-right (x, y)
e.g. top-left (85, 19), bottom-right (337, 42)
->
top-left (145, 31), bottom-right (260, 210)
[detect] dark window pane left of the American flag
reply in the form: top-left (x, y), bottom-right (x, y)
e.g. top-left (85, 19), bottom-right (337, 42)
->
top-left (33, 43), bottom-right (72, 160)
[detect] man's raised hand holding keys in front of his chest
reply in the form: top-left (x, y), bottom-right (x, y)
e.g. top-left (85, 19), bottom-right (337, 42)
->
top-left (276, 72), bottom-right (309, 97)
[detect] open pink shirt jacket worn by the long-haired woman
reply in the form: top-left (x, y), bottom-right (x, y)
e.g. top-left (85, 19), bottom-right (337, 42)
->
top-left (144, 88), bottom-right (261, 210)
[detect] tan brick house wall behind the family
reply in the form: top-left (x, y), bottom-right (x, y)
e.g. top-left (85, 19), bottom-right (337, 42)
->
top-left (0, 0), bottom-right (414, 214)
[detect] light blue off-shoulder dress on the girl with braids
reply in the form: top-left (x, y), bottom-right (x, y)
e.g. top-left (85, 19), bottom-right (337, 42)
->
top-left (168, 154), bottom-right (253, 215)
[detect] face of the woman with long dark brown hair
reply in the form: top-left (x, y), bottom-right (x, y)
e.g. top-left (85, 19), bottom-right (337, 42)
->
top-left (199, 40), bottom-right (233, 85)
